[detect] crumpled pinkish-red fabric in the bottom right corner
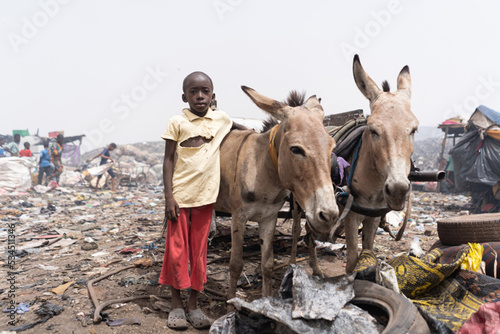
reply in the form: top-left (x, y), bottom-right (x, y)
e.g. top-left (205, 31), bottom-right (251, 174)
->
top-left (459, 302), bottom-right (500, 334)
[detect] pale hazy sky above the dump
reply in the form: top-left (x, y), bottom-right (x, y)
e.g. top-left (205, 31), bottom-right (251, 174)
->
top-left (0, 0), bottom-right (500, 151)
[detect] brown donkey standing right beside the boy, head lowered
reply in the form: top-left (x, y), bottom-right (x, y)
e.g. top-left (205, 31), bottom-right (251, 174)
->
top-left (215, 86), bottom-right (338, 298)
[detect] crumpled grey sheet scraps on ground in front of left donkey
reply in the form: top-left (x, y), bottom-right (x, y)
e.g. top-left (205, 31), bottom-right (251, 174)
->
top-left (210, 265), bottom-right (380, 334)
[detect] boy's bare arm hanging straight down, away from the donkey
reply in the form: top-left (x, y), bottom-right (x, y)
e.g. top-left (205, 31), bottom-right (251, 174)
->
top-left (163, 139), bottom-right (179, 222)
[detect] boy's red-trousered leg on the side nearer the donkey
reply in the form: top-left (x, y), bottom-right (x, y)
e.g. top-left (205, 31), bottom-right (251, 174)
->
top-left (187, 204), bottom-right (214, 312)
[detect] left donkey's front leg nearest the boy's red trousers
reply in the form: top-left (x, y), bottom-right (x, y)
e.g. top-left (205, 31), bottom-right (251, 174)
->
top-left (227, 214), bottom-right (246, 299)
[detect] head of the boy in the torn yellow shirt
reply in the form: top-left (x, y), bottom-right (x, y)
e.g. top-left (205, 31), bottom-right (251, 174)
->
top-left (182, 74), bottom-right (215, 117)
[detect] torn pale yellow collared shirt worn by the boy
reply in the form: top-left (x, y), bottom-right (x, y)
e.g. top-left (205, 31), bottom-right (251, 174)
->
top-left (161, 108), bottom-right (233, 208)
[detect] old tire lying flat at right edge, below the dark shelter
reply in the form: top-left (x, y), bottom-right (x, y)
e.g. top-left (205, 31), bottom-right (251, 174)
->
top-left (437, 213), bottom-right (500, 246)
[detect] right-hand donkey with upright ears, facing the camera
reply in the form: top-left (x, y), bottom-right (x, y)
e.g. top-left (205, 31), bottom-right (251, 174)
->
top-left (342, 55), bottom-right (419, 273)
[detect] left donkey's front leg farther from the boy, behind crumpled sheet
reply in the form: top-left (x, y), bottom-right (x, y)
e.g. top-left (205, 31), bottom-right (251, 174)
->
top-left (259, 217), bottom-right (278, 297)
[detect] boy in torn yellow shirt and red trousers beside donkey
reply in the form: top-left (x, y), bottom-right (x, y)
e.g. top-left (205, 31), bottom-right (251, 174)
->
top-left (159, 72), bottom-right (246, 329)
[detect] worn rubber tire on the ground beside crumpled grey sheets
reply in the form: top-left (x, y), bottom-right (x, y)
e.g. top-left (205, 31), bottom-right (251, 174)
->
top-left (350, 280), bottom-right (431, 334)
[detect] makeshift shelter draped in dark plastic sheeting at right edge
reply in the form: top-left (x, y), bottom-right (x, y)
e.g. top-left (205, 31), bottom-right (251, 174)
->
top-left (450, 105), bottom-right (500, 211)
